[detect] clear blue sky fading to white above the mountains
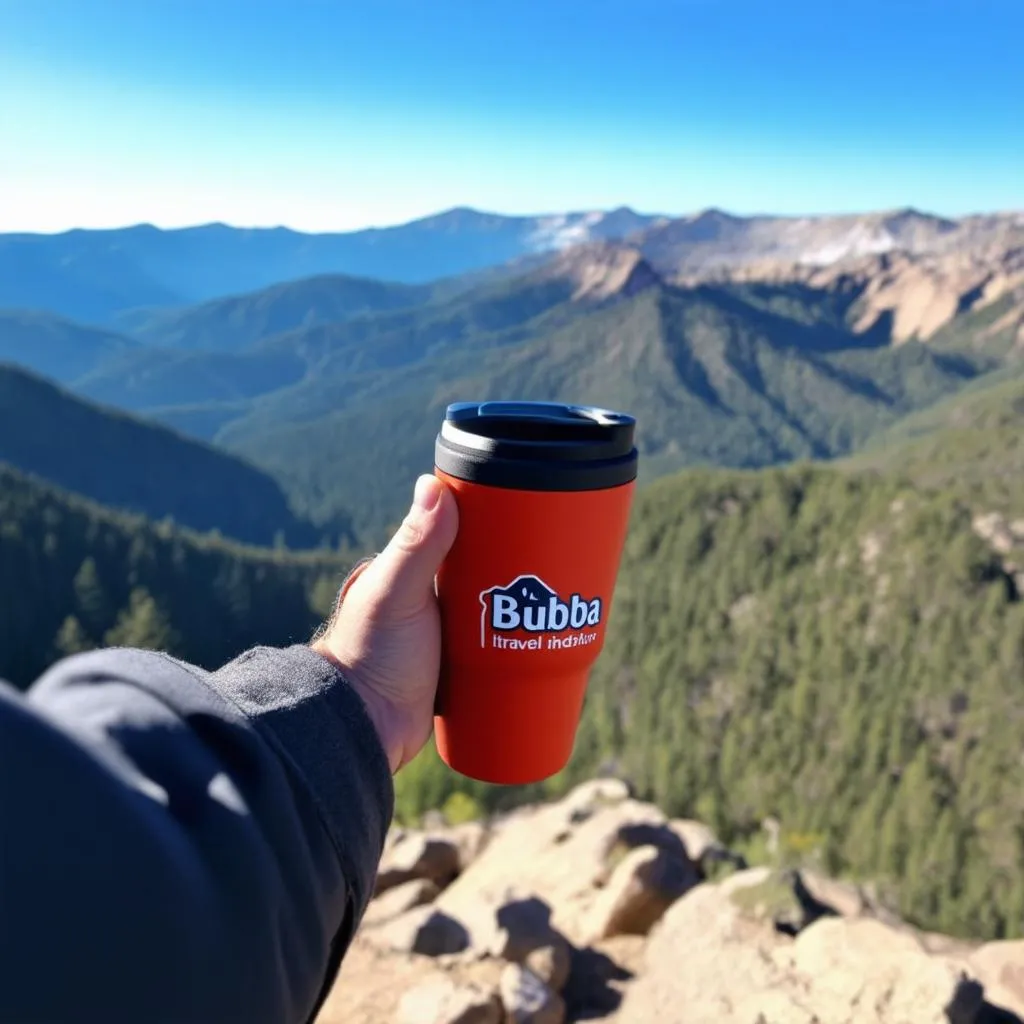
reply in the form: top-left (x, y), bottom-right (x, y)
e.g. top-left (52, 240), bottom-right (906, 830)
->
top-left (0, 0), bottom-right (1024, 230)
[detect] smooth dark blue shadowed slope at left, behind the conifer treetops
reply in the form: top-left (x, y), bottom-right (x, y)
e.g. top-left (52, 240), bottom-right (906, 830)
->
top-left (0, 365), bottom-right (349, 547)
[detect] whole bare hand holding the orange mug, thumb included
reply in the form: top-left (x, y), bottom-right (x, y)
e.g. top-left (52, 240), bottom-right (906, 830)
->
top-left (312, 476), bottom-right (459, 772)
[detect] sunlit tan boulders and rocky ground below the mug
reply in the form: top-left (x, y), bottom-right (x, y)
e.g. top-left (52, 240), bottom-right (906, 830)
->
top-left (317, 779), bottom-right (1024, 1024)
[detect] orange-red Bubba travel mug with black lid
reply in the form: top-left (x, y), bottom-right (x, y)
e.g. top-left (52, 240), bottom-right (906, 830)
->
top-left (434, 401), bottom-right (638, 784)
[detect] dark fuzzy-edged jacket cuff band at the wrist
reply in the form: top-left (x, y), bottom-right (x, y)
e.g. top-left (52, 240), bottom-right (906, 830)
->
top-left (209, 645), bottom-right (394, 923)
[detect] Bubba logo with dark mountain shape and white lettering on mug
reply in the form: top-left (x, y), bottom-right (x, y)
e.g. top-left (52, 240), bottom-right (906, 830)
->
top-left (480, 575), bottom-right (601, 649)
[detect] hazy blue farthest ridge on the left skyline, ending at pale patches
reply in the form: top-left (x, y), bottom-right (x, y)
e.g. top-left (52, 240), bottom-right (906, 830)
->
top-left (0, 208), bottom-right (658, 324)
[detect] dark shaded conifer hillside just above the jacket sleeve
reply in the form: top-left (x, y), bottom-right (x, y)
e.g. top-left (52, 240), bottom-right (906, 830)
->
top-left (0, 464), bottom-right (343, 686)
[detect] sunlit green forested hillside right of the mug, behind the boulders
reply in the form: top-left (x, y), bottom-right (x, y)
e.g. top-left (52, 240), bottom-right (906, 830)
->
top-left (399, 446), bottom-right (1024, 936)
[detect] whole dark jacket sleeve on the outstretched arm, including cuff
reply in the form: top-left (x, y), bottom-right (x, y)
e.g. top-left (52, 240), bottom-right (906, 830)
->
top-left (0, 647), bottom-right (393, 1024)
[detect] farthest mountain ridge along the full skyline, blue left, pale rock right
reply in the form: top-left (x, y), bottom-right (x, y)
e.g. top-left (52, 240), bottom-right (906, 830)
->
top-left (0, 201), bottom-right (1024, 326)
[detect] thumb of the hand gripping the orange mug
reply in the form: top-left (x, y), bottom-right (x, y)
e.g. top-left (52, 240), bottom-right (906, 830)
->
top-left (359, 475), bottom-right (459, 614)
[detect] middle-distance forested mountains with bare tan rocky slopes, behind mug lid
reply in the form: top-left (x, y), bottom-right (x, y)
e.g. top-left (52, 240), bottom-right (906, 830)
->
top-left (0, 203), bottom-right (1024, 539)
